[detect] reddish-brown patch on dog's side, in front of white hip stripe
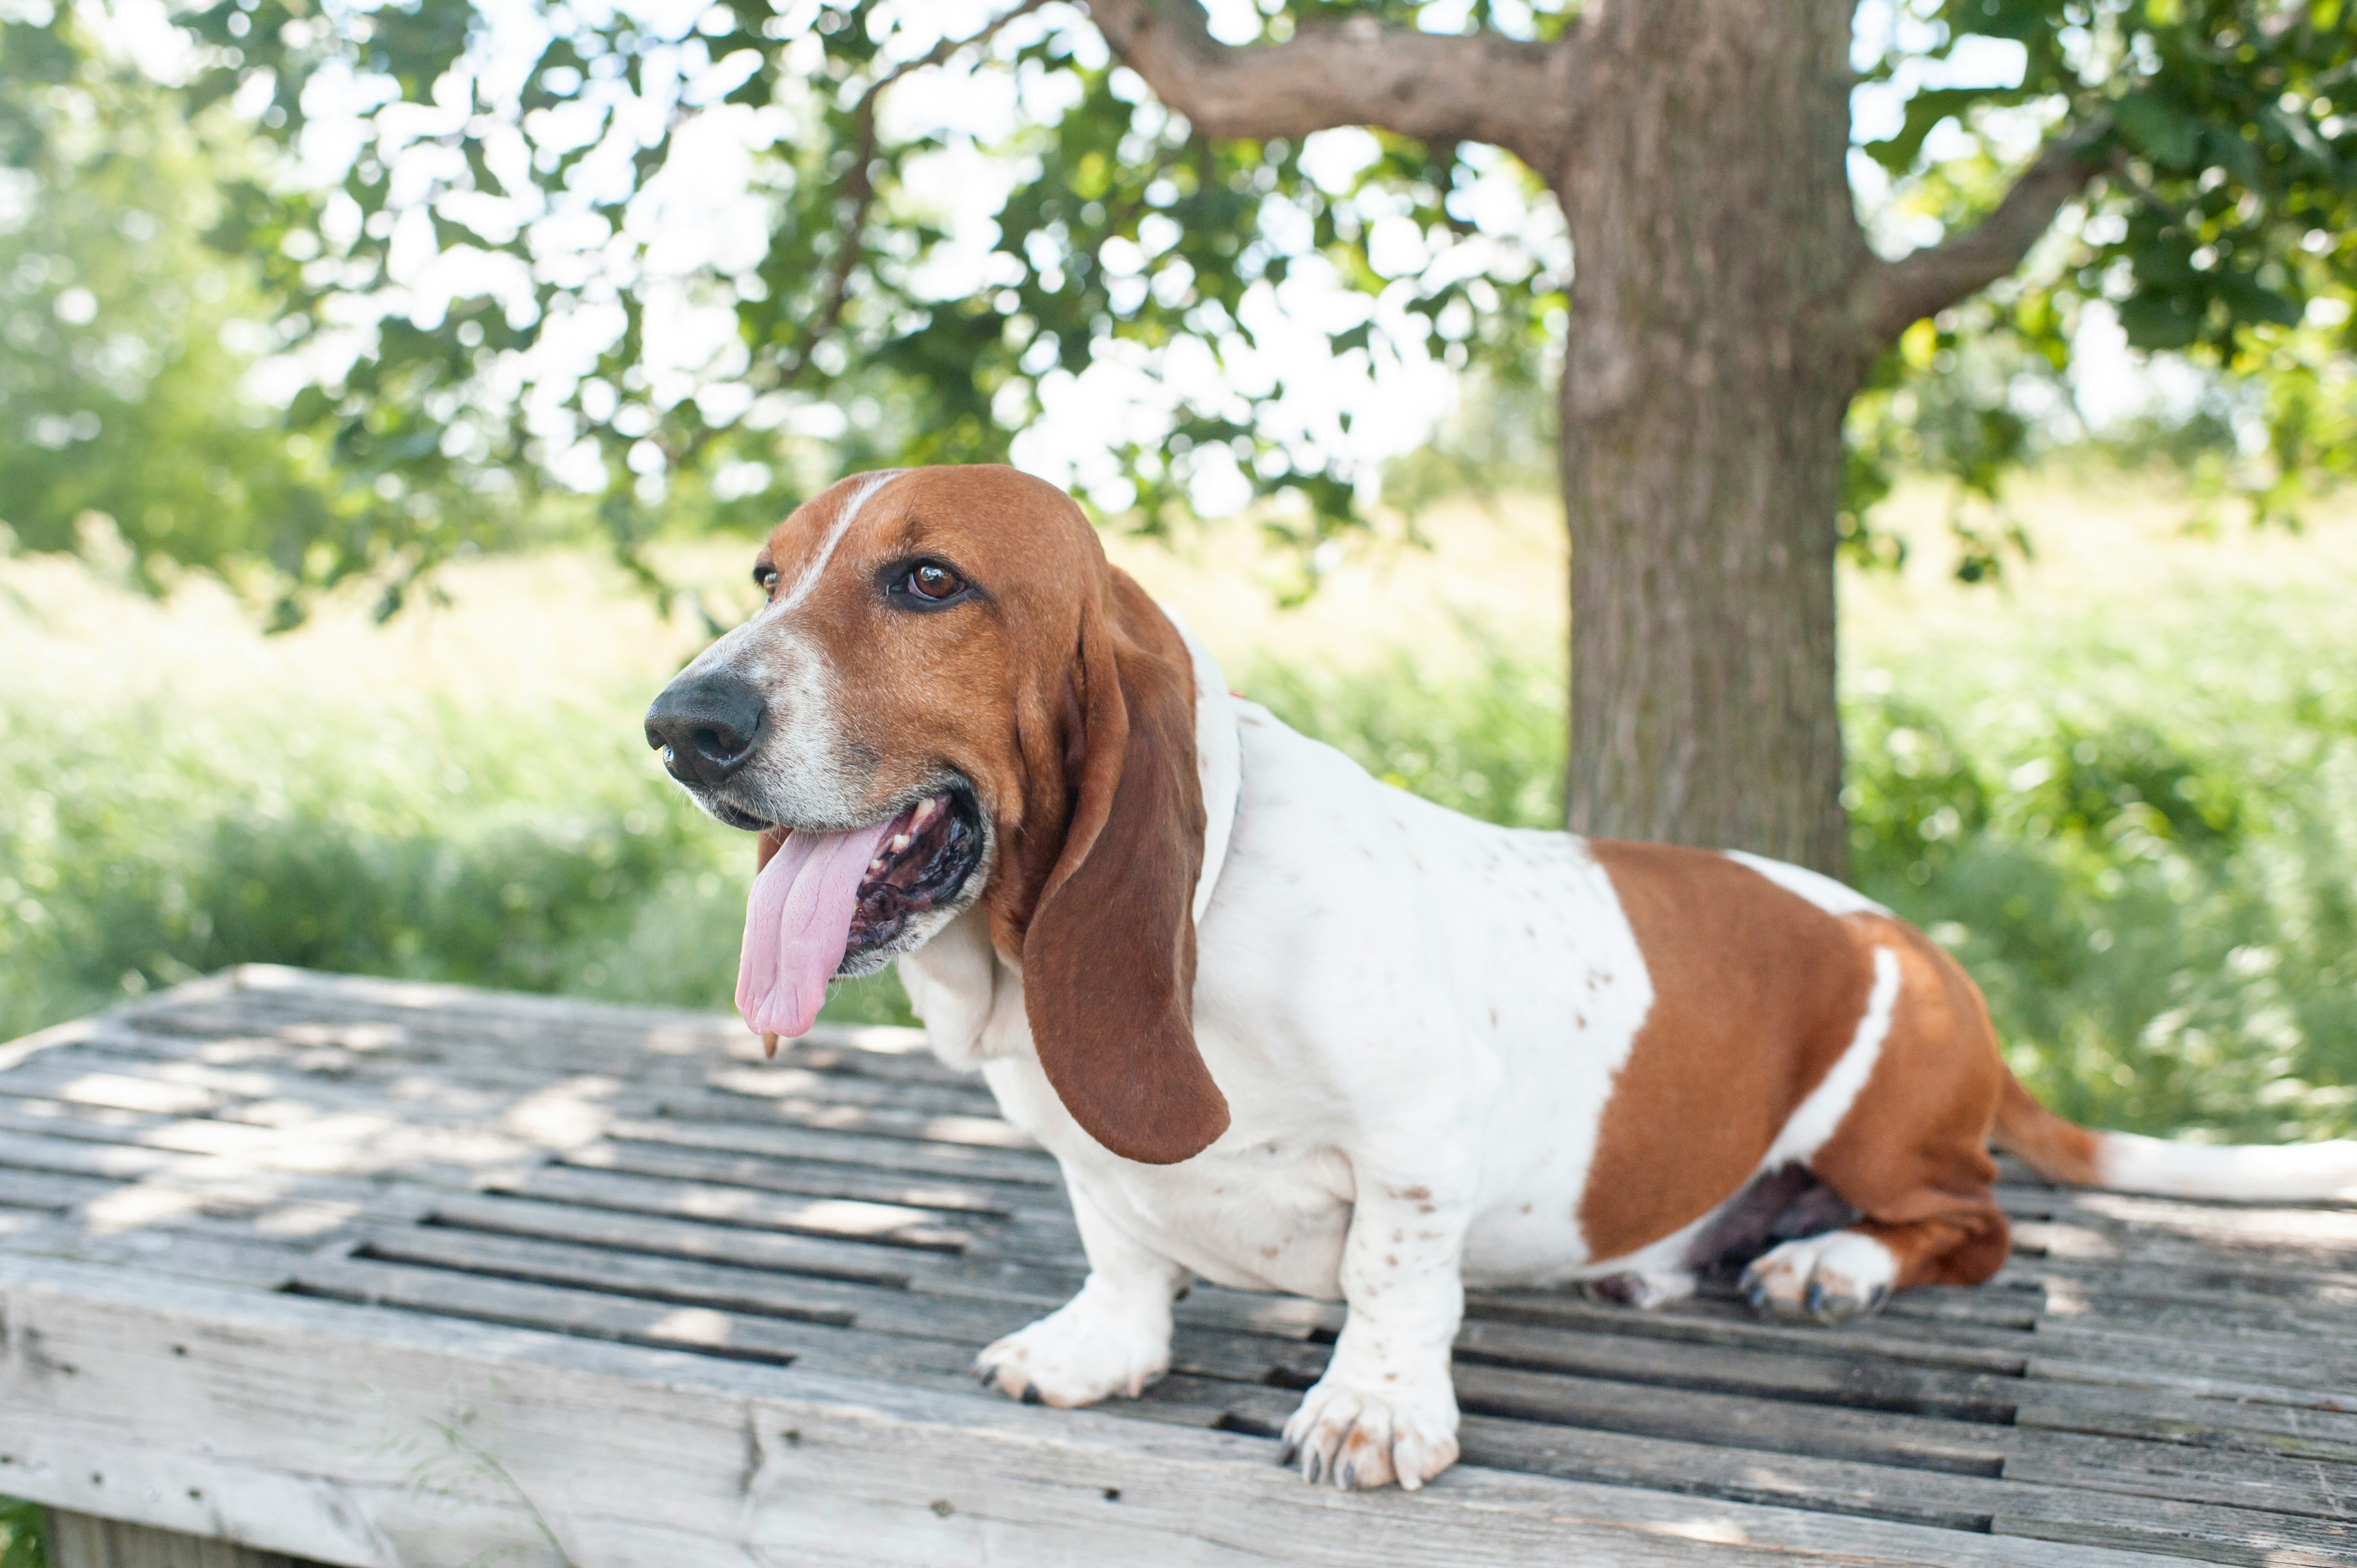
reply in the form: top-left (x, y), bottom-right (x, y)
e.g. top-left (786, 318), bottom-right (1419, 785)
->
top-left (1579, 840), bottom-right (1874, 1259)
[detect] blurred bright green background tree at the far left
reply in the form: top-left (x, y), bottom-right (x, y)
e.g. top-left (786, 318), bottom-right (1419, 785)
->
top-left (0, 12), bottom-right (532, 620)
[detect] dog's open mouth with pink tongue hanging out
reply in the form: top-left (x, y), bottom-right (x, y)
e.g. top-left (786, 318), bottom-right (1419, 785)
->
top-left (735, 788), bottom-right (983, 1035)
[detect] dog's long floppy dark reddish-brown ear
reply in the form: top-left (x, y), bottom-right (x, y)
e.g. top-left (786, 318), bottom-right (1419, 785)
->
top-left (1023, 573), bottom-right (1228, 1165)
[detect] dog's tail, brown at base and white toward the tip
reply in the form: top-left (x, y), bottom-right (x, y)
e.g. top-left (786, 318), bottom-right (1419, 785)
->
top-left (1994, 1073), bottom-right (2357, 1202)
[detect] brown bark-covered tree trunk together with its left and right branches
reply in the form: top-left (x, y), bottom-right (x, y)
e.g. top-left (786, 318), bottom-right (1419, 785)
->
top-left (1089, 0), bottom-right (2105, 877)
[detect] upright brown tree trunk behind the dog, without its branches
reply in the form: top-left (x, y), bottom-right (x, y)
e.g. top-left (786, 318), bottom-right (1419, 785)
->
top-left (1553, 0), bottom-right (1869, 877)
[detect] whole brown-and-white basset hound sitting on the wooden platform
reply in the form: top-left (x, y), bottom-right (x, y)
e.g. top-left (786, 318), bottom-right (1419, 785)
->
top-left (646, 467), bottom-right (2357, 1488)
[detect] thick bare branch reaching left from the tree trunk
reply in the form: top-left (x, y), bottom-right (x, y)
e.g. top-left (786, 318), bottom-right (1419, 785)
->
top-left (1089, 0), bottom-right (1570, 168)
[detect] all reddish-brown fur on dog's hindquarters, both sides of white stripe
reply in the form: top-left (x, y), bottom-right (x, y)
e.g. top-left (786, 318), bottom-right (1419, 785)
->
top-left (1579, 840), bottom-right (2017, 1288)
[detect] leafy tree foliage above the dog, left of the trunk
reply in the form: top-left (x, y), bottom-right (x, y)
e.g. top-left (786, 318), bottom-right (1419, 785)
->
top-left (174, 0), bottom-right (1560, 603)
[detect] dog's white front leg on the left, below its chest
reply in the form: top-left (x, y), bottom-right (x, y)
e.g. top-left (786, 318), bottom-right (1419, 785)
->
top-left (973, 1176), bottom-right (1186, 1405)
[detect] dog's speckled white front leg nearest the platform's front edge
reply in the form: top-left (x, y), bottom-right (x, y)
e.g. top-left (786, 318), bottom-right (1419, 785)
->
top-left (1280, 1172), bottom-right (1473, 1490)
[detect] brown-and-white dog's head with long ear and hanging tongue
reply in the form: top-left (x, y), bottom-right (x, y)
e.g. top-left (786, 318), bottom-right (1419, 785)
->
top-left (646, 467), bottom-right (1228, 1163)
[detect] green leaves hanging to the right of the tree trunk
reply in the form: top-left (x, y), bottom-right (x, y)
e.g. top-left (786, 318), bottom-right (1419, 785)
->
top-left (1843, 0), bottom-right (2357, 563)
